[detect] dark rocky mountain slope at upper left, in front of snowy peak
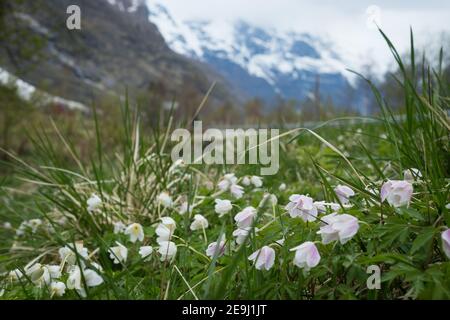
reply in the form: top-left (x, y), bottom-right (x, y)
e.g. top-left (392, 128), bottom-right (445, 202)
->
top-left (0, 0), bottom-right (234, 104)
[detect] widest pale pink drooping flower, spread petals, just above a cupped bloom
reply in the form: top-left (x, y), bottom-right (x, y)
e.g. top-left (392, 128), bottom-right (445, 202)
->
top-left (317, 213), bottom-right (359, 244)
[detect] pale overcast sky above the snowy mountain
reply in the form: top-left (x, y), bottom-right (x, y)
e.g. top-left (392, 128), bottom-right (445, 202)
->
top-left (161, 0), bottom-right (450, 75)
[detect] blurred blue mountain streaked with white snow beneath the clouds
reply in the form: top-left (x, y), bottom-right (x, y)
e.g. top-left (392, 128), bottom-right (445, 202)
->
top-left (141, 0), bottom-right (351, 103)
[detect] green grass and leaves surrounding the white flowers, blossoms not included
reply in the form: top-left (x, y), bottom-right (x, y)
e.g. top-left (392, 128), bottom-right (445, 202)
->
top-left (0, 28), bottom-right (450, 299)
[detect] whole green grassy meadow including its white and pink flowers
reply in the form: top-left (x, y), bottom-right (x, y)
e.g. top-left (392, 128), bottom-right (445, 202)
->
top-left (0, 31), bottom-right (450, 300)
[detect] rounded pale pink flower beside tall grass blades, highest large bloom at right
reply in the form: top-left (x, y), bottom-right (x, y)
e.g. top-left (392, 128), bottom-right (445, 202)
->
top-left (380, 180), bottom-right (413, 207)
